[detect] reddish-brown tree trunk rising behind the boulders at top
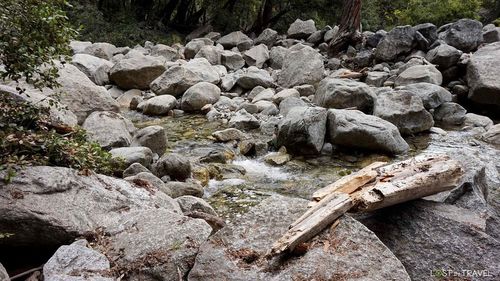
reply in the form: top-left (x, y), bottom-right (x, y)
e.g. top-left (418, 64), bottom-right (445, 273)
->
top-left (328, 0), bottom-right (361, 56)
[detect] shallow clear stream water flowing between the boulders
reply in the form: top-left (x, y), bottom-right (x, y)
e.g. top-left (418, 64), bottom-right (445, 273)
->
top-left (129, 110), bottom-right (500, 220)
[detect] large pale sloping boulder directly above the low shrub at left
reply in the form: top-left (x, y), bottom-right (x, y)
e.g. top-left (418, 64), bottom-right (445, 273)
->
top-left (55, 64), bottom-right (119, 124)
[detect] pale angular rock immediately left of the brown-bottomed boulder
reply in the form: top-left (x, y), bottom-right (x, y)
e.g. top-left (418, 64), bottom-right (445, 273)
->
top-left (71, 54), bottom-right (113, 86)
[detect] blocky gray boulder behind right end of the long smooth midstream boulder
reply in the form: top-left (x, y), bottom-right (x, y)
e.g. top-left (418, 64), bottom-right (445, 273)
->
top-left (373, 90), bottom-right (434, 135)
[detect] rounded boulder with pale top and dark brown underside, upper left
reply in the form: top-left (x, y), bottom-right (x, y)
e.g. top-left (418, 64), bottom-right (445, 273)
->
top-left (109, 56), bottom-right (165, 90)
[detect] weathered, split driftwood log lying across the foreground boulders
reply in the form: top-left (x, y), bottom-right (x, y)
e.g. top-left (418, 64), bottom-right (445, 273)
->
top-left (267, 155), bottom-right (463, 258)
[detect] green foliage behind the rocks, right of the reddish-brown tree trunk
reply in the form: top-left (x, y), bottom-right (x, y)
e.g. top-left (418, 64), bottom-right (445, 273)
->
top-left (394, 0), bottom-right (482, 26)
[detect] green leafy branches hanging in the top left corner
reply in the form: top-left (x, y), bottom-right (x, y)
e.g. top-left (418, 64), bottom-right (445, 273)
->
top-left (0, 0), bottom-right (77, 88)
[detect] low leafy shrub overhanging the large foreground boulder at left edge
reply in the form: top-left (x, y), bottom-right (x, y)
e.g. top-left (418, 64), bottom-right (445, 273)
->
top-left (0, 95), bottom-right (120, 177)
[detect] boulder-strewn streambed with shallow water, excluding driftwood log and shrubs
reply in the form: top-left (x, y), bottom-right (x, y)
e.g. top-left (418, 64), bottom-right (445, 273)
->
top-left (0, 19), bottom-right (500, 280)
